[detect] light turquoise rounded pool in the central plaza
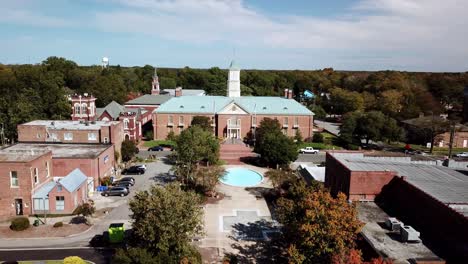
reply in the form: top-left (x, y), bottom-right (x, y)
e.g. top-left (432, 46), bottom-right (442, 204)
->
top-left (221, 168), bottom-right (263, 187)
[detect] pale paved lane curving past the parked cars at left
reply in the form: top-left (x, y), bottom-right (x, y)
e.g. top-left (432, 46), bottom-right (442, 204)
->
top-left (0, 161), bottom-right (171, 250)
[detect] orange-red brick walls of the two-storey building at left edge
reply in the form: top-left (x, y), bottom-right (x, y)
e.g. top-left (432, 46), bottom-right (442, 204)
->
top-left (0, 152), bottom-right (54, 220)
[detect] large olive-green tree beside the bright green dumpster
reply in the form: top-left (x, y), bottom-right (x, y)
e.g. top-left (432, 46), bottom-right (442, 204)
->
top-left (129, 184), bottom-right (203, 259)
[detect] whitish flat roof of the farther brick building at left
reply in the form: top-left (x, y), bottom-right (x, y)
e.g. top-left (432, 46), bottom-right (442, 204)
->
top-left (22, 120), bottom-right (119, 130)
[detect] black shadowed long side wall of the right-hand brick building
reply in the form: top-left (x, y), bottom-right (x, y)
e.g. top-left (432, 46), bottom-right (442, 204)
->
top-left (377, 177), bottom-right (468, 263)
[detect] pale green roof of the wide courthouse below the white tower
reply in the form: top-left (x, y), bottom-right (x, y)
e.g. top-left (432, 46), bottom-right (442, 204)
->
top-left (155, 96), bottom-right (314, 115)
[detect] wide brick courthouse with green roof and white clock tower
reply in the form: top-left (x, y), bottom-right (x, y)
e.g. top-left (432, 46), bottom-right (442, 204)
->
top-left (153, 62), bottom-right (313, 139)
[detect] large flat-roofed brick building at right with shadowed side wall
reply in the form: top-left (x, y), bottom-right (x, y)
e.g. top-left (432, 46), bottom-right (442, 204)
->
top-left (325, 152), bottom-right (468, 263)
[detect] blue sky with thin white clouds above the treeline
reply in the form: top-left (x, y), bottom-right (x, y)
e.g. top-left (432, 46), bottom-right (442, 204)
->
top-left (0, 0), bottom-right (468, 72)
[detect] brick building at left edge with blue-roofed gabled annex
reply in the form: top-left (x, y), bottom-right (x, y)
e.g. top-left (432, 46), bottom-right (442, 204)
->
top-left (0, 149), bottom-right (88, 220)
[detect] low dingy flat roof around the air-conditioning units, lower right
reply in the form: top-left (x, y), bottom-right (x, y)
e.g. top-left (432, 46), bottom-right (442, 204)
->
top-left (357, 202), bottom-right (440, 263)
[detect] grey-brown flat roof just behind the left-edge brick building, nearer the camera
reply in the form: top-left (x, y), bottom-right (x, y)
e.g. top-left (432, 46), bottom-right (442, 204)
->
top-left (3, 143), bottom-right (112, 159)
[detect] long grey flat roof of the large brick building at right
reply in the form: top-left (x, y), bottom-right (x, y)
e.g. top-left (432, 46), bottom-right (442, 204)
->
top-left (329, 152), bottom-right (468, 213)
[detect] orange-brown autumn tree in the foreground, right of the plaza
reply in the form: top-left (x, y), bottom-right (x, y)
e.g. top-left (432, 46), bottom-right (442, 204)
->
top-left (277, 184), bottom-right (362, 263)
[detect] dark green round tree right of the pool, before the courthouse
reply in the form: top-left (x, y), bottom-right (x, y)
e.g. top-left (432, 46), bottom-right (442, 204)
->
top-left (254, 118), bottom-right (298, 166)
